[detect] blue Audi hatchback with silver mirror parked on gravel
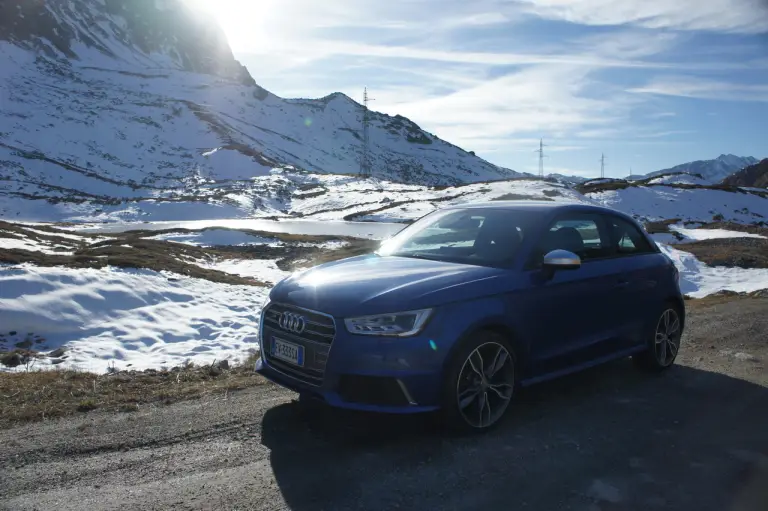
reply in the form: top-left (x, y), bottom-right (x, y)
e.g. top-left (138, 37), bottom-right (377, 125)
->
top-left (256, 201), bottom-right (685, 430)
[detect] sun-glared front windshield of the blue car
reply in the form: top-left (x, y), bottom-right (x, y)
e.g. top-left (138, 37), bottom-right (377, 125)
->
top-left (377, 208), bottom-right (541, 266)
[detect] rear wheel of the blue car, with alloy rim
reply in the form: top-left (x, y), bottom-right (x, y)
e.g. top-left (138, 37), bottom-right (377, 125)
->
top-left (632, 302), bottom-right (683, 373)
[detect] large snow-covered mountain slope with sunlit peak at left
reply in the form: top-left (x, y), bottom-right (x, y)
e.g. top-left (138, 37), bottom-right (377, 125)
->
top-left (0, 0), bottom-right (518, 211)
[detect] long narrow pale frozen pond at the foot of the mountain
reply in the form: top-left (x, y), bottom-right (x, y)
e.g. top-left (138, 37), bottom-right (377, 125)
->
top-left (69, 218), bottom-right (405, 239)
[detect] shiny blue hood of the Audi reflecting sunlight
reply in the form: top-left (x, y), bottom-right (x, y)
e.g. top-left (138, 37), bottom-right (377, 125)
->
top-left (270, 254), bottom-right (509, 317)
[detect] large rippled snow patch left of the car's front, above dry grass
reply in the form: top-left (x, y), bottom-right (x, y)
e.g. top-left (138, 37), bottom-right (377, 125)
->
top-left (0, 265), bottom-right (267, 372)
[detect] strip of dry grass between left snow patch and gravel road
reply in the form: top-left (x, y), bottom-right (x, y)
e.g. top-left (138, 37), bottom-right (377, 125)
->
top-left (0, 356), bottom-right (265, 428)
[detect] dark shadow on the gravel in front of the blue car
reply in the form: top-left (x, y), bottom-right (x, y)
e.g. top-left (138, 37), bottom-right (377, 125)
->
top-left (262, 361), bottom-right (768, 511)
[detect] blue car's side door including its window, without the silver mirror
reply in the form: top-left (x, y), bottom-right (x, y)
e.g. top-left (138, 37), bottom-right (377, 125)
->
top-left (521, 213), bottom-right (619, 378)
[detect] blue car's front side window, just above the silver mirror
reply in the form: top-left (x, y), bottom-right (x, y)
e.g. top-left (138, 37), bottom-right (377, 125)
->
top-left (530, 215), bottom-right (612, 266)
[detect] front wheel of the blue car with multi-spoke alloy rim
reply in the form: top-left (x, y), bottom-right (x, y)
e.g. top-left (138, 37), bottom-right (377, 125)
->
top-left (442, 330), bottom-right (518, 433)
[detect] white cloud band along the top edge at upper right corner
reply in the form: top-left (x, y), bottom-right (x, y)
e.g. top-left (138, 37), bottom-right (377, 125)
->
top-left (518, 0), bottom-right (768, 34)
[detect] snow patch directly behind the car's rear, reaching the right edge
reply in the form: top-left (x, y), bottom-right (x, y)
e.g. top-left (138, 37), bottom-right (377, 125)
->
top-left (659, 243), bottom-right (768, 298)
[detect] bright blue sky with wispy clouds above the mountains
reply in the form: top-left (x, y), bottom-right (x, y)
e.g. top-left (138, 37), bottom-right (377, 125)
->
top-left (186, 0), bottom-right (768, 177)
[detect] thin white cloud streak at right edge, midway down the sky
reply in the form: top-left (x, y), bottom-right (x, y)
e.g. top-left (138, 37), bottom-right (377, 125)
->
top-left (629, 76), bottom-right (768, 102)
